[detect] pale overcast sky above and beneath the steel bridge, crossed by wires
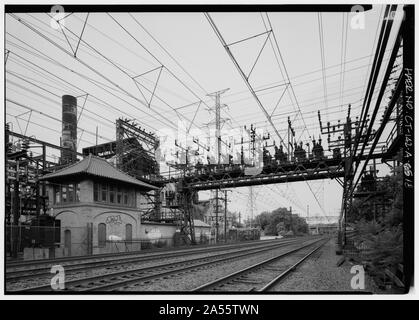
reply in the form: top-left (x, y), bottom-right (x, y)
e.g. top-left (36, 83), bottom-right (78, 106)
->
top-left (5, 5), bottom-right (402, 224)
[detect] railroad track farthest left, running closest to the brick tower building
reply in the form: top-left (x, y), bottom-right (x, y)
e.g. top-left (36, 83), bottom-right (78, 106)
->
top-left (6, 239), bottom-right (302, 281)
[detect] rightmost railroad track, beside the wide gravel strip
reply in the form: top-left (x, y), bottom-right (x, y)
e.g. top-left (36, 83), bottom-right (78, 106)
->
top-left (191, 238), bottom-right (329, 292)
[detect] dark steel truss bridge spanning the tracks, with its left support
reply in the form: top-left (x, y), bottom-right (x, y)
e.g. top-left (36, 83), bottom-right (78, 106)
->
top-left (166, 147), bottom-right (394, 242)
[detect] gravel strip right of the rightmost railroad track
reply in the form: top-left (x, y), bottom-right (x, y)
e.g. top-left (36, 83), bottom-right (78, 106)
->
top-left (270, 238), bottom-right (379, 293)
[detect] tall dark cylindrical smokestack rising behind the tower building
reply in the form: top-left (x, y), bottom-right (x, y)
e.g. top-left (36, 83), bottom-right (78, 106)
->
top-left (61, 95), bottom-right (77, 164)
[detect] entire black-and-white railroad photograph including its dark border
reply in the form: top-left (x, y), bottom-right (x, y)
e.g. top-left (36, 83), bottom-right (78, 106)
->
top-left (1, 2), bottom-right (415, 298)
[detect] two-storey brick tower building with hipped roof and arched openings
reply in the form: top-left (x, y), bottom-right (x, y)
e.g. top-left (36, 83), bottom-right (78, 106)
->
top-left (40, 155), bottom-right (158, 255)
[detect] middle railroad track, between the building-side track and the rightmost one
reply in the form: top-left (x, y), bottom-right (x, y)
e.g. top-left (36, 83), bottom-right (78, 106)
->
top-left (8, 238), bottom-right (316, 292)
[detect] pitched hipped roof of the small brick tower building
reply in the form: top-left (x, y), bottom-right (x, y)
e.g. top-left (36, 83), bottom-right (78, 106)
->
top-left (40, 154), bottom-right (158, 190)
